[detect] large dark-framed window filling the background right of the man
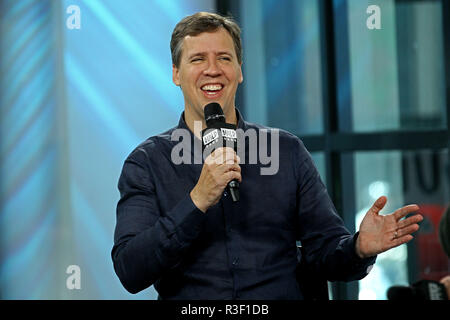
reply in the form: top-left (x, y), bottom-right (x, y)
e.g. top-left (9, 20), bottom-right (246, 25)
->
top-left (225, 0), bottom-right (450, 299)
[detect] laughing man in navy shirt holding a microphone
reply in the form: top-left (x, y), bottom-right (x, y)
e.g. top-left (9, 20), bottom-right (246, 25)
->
top-left (112, 13), bottom-right (422, 299)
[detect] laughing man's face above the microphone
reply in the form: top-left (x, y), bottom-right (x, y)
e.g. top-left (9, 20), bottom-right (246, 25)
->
top-left (172, 28), bottom-right (243, 120)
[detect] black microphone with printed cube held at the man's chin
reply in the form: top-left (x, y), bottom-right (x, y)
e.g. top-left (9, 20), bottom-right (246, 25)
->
top-left (202, 102), bottom-right (239, 202)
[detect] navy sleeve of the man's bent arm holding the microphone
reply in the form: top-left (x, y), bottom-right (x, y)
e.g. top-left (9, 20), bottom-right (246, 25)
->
top-left (111, 148), bottom-right (205, 293)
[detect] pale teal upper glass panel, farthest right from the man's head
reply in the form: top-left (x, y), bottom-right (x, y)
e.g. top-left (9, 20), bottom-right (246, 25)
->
top-left (344, 0), bottom-right (446, 132)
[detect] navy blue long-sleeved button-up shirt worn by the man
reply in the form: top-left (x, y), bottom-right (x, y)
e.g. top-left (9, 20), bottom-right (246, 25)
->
top-left (111, 110), bottom-right (376, 299)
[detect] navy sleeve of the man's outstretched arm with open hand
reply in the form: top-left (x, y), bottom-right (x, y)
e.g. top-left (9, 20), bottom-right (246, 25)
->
top-left (295, 140), bottom-right (376, 281)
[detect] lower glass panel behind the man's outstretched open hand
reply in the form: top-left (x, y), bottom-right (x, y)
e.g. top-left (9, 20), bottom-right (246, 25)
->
top-left (355, 151), bottom-right (450, 299)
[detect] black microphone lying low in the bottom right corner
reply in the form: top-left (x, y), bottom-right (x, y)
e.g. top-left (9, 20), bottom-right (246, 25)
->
top-left (387, 280), bottom-right (448, 301)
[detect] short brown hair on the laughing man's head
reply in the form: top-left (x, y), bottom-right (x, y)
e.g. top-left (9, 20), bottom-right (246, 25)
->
top-left (170, 12), bottom-right (242, 68)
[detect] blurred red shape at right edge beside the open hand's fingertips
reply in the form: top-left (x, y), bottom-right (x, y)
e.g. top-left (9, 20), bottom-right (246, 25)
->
top-left (415, 204), bottom-right (450, 281)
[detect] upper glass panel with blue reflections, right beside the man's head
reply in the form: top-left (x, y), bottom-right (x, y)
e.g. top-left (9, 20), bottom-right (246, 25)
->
top-left (240, 0), bottom-right (323, 135)
